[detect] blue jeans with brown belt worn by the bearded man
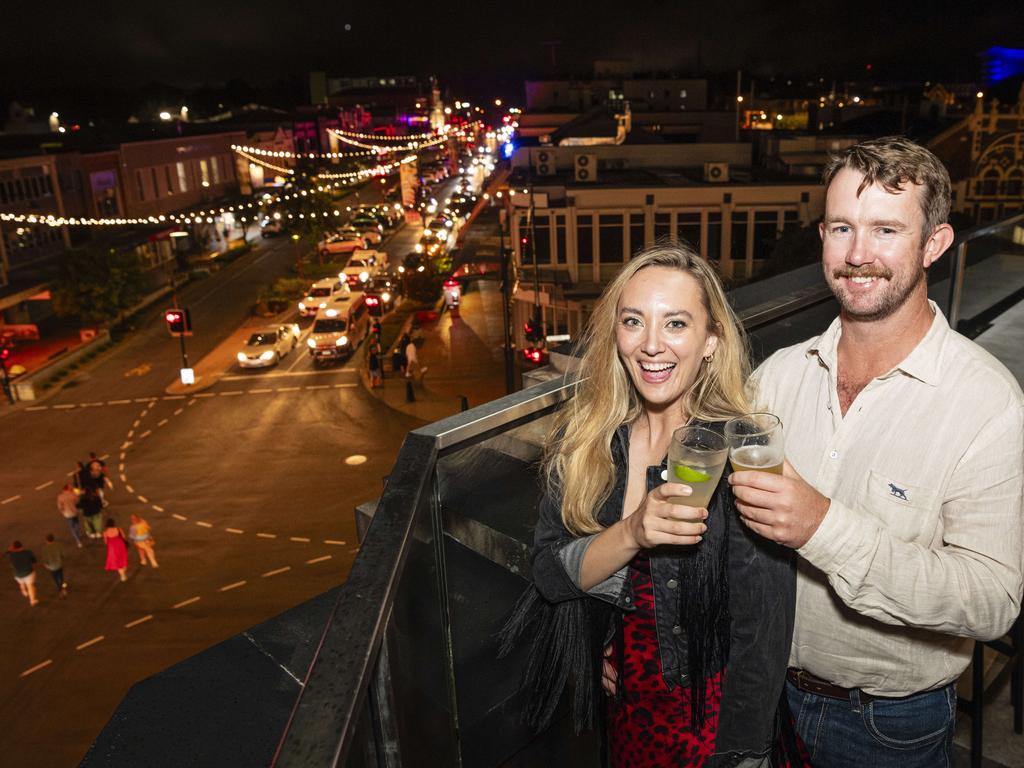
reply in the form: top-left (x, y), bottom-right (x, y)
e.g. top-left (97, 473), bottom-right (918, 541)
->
top-left (785, 681), bottom-right (956, 768)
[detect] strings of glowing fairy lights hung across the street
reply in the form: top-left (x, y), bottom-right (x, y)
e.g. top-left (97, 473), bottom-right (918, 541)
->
top-left (0, 121), bottom-right (480, 227)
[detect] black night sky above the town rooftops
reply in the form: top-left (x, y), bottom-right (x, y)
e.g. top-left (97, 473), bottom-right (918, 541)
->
top-left (0, 0), bottom-right (1024, 94)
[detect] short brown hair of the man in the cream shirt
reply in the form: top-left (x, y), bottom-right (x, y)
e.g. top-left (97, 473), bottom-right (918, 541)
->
top-left (822, 136), bottom-right (952, 241)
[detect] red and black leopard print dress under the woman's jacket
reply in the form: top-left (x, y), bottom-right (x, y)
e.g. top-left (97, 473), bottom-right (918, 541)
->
top-left (608, 553), bottom-right (722, 768)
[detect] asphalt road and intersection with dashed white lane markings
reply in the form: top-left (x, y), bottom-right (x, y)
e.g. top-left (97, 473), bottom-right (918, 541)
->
top-left (0, 182), bottom-right (448, 768)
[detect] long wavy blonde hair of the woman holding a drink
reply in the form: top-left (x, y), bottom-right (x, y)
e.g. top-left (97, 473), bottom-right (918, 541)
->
top-left (545, 243), bottom-right (751, 536)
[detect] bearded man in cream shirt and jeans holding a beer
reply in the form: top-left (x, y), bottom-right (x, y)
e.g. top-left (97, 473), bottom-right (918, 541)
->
top-left (730, 137), bottom-right (1024, 768)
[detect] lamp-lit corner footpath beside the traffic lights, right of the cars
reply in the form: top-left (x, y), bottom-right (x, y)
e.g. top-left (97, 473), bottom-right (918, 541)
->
top-left (359, 280), bottom-right (506, 423)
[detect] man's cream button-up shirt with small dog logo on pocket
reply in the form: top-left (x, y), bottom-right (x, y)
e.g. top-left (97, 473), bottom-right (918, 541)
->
top-left (754, 302), bottom-right (1024, 696)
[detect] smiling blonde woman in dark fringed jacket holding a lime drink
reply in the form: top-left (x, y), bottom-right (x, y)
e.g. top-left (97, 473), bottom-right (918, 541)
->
top-left (502, 244), bottom-right (796, 768)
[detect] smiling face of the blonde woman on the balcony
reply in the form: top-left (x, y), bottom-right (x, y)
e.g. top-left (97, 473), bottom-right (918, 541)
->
top-left (615, 266), bottom-right (718, 411)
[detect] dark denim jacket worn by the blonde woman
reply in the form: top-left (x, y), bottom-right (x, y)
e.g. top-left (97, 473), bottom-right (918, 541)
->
top-left (532, 424), bottom-right (796, 766)
